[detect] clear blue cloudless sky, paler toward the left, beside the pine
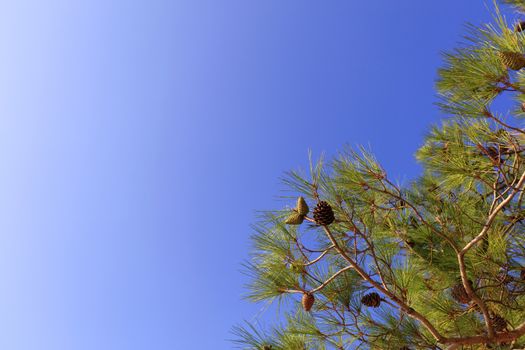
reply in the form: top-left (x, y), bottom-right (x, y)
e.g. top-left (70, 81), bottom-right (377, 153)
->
top-left (0, 0), bottom-right (502, 350)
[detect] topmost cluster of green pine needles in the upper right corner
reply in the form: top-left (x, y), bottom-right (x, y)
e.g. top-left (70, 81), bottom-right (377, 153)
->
top-left (437, 4), bottom-right (525, 117)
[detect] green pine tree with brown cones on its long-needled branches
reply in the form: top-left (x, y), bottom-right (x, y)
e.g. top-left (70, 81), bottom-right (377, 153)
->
top-left (235, 0), bottom-right (525, 350)
